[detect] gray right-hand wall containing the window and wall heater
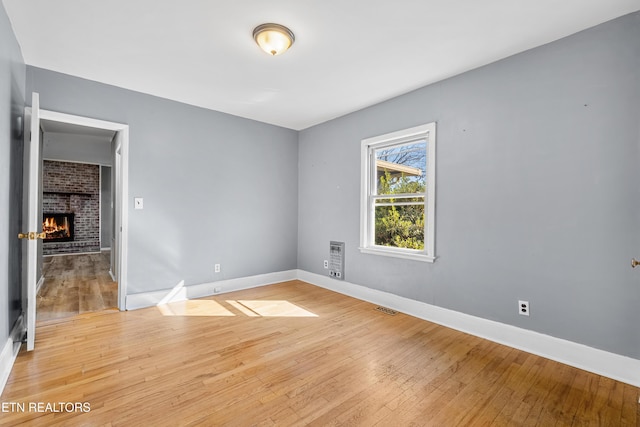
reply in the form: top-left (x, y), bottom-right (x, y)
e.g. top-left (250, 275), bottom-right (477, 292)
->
top-left (298, 13), bottom-right (640, 358)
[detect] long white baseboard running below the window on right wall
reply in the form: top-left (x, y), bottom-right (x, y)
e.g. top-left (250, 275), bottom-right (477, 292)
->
top-left (297, 270), bottom-right (640, 387)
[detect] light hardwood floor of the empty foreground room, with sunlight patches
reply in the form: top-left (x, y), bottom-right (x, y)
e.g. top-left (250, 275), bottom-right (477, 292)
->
top-left (0, 281), bottom-right (640, 426)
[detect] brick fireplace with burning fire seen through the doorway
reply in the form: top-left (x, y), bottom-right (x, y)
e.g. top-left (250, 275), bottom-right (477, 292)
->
top-left (42, 160), bottom-right (100, 255)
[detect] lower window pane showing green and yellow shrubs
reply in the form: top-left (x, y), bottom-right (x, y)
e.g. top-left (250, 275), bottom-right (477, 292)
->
top-left (374, 202), bottom-right (424, 250)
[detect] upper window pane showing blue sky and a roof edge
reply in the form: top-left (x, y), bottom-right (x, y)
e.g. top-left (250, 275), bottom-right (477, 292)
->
top-left (374, 140), bottom-right (427, 194)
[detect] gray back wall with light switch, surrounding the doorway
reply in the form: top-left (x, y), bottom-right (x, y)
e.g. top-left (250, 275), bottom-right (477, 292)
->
top-left (27, 67), bottom-right (298, 294)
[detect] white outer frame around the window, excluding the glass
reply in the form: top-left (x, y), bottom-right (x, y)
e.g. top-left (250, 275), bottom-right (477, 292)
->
top-left (359, 122), bottom-right (436, 262)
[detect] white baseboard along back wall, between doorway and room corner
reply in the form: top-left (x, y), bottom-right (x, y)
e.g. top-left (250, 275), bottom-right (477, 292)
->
top-left (126, 270), bottom-right (298, 310)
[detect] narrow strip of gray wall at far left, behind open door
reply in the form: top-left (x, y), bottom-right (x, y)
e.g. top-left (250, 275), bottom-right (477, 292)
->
top-left (0, 4), bottom-right (25, 346)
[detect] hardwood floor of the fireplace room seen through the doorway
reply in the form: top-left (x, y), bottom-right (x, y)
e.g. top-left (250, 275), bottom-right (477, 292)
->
top-left (36, 251), bottom-right (118, 321)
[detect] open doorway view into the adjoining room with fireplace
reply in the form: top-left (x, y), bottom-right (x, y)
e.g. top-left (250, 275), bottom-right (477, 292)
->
top-left (36, 119), bottom-right (118, 322)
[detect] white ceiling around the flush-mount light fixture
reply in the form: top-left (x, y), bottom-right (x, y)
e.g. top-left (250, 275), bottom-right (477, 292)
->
top-left (3, 0), bottom-right (640, 130)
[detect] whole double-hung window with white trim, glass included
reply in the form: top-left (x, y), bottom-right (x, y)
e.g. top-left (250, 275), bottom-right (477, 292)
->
top-left (360, 122), bottom-right (436, 262)
